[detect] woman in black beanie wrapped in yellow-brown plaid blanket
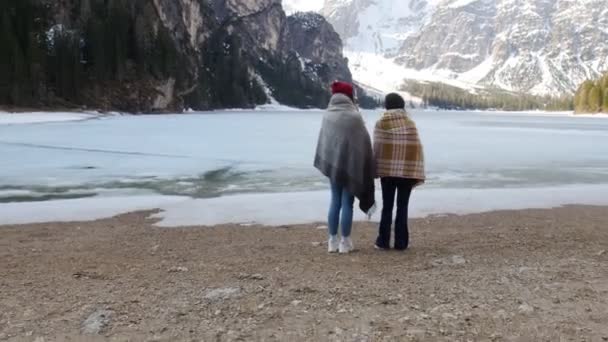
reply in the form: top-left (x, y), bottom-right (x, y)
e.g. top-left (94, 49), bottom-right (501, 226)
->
top-left (374, 93), bottom-right (425, 250)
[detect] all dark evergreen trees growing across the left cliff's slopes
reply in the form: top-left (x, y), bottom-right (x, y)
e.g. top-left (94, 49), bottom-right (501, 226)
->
top-left (0, 0), bottom-right (368, 112)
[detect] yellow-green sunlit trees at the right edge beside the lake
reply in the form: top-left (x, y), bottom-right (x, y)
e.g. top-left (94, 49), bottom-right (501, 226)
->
top-left (574, 73), bottom-right (608, 113)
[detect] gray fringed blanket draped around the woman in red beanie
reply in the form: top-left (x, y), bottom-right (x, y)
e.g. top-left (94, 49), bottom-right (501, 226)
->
top-left (315, 94), bottom-right (375, 215)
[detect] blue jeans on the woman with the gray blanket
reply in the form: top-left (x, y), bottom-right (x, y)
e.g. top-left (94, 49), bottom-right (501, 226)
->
top-left (328, 183), bottom-right (355, 237)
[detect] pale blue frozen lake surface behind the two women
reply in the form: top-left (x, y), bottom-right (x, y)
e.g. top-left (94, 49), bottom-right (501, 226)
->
top-left (0, 111), bottom-right (608, 227)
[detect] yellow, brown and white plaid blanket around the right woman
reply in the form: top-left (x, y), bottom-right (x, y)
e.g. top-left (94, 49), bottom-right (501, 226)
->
top-left (374, 109), bottom-right (426, 184)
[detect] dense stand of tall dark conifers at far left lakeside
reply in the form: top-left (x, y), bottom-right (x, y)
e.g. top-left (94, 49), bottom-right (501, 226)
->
top-left (0, 0), bottom-right (179, 106)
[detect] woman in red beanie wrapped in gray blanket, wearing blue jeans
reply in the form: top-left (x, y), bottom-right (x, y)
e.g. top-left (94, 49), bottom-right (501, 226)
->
top-left (315, 82), bottom-right (375, 253)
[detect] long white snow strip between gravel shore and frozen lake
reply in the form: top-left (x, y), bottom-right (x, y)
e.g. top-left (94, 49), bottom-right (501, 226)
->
top-left (0, 185), bottom-right (608, 227)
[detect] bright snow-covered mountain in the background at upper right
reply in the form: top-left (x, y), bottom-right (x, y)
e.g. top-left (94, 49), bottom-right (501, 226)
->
top-left (286, 0), bottom-right (608, 94)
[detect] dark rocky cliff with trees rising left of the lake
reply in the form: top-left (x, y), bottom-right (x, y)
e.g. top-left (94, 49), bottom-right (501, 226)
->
top-left (0, 0), bottom-right (364, 112)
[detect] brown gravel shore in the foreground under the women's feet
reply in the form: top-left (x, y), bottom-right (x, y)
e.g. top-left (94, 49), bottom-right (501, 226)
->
top-left (0, 207), bottom-right (608, 342)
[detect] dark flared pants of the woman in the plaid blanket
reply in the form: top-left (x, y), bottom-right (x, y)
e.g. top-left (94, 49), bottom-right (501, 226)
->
top-left (376, 177), bottom-right (418, 250)
